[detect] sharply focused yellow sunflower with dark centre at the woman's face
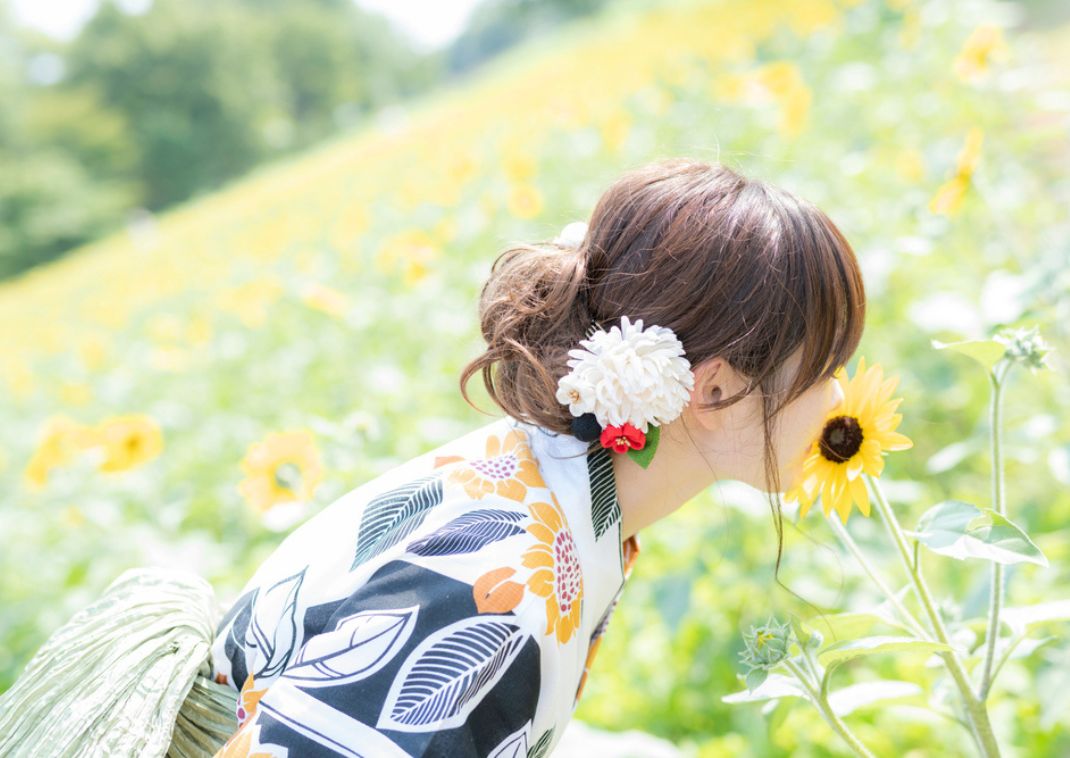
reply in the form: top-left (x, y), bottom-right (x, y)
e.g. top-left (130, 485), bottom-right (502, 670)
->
top-left (785, 358), bottom-right (914, 524)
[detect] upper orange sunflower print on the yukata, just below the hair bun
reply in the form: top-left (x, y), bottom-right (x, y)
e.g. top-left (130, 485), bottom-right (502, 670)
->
top-left (434, 429), bottom-right (546, 502)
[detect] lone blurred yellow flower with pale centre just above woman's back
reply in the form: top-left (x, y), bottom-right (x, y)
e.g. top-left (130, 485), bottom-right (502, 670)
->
top-left (238, 429), bottom-right (323, 512)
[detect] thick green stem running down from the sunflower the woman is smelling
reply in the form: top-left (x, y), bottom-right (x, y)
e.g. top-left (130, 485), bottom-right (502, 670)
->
top-left (862, 473), bottom-right (999, 758)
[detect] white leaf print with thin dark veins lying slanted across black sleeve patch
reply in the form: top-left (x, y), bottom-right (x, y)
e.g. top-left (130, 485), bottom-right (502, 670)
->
top-left (285, 605), bottom-right (419, 687)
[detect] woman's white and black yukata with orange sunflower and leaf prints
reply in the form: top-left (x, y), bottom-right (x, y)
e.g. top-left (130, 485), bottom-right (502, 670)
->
top-left (212, 415), bottom-right (640, 758)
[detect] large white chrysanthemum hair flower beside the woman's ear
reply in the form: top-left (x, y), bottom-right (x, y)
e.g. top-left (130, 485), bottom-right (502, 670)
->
top-left (556, 316), bottom-right (694, 433)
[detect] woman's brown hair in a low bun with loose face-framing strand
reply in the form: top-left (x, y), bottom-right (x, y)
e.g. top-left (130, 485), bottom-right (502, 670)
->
top-left (460, 158), bottom-right (866, 586)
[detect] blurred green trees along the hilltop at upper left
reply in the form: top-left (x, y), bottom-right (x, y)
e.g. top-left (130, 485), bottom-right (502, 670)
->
top-left (0, 0), bottom-right (603, 277)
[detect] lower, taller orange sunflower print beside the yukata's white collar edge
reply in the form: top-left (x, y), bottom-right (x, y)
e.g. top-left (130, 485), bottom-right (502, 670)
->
top-left (522, 492), bottom-right (583, 645)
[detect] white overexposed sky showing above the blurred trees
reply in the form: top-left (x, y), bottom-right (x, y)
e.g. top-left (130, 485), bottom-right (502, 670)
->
top-left (11, 0), bottom-right (480, 51)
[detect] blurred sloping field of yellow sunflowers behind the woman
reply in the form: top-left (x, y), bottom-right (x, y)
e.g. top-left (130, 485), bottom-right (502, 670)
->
top-left (0, 0), bottom-right (1070, 757)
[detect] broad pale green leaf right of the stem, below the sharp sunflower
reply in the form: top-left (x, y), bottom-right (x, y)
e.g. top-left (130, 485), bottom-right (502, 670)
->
top-left (904, 500), bottom-right (1048, 566)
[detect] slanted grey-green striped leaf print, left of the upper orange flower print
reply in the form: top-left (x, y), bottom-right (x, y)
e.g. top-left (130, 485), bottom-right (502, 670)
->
top-left (350, 472), bottom-right (442, 571)
